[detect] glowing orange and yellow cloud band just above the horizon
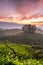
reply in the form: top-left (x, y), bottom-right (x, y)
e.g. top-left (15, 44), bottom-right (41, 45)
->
top-left (0, 12), bottom-right (43, 25)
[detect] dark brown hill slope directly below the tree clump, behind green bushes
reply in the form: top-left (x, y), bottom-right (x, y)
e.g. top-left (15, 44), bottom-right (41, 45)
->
top-left (0, 31), bottom-right (43, 45)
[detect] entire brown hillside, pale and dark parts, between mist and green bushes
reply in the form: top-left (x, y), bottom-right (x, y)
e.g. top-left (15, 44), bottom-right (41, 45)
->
top-left (0, 29), bottom-right (43, 45)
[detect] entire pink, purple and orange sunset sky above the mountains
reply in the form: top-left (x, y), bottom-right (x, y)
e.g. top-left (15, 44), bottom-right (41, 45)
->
top-left (0, 0), bottom-right (43, 26)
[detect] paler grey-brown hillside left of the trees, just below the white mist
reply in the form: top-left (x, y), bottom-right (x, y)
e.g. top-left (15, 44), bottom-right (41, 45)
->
top-left (0, 29), bottom-right (22, 37)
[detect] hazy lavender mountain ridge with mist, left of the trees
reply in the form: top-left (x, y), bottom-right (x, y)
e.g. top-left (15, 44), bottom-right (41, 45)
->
top-left (0, 22), bottom-right (22, 29)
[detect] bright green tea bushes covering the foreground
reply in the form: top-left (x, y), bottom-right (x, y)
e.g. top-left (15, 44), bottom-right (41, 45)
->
top-left (0, 43), bottom-right (43, 65)
